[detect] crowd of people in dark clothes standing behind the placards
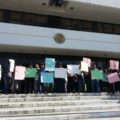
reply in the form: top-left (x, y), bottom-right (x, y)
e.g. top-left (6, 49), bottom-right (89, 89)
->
top-left (0, 59), bottom-right (120, 94)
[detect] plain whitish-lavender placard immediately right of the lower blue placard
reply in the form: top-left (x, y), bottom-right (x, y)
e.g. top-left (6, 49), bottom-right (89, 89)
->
top-left (55, 68), bottom-right (67, 79)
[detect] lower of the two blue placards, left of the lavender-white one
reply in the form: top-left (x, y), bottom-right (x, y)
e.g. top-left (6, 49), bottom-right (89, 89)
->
top-left (41, 72), bottom-right (54, 83)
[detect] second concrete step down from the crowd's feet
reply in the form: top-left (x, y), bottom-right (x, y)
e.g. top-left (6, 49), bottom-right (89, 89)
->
top-left (0, 100), bottom-right (120, 108)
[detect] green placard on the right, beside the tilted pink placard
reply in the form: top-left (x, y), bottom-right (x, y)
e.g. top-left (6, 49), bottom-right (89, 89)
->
top-left (91, 69), bottom-right (104, 80)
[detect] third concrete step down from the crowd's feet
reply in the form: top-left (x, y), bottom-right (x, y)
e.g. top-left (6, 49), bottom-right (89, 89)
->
top-left (0, 104), bottom-right (120, 116)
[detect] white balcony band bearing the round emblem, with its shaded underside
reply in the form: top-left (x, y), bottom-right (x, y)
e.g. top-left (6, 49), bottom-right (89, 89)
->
top-left (0, 23), bottom-right (120, 58)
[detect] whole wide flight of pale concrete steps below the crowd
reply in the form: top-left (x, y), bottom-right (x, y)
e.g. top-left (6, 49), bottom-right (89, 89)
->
top-left (0, 93), bottom-right (120, 120)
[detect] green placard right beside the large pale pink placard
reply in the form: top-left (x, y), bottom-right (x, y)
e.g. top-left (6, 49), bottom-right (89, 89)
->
top-left (25, 68), bottom-right (37, 78)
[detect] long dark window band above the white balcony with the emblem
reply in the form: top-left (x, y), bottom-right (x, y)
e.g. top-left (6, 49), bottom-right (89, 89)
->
top-left (0, 10), bottom-right (120, 34)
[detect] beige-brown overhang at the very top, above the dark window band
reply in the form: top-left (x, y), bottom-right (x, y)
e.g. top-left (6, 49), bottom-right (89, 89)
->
top-left (0, 0), bottom-right (120, 24)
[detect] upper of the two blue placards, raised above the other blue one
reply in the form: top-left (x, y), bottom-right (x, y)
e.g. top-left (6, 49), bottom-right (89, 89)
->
top-left (45, 58), bottom-right (55, 71)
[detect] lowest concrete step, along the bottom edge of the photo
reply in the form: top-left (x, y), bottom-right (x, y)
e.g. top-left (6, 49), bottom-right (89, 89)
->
top-left (0, 110), bottom-right (120, 120)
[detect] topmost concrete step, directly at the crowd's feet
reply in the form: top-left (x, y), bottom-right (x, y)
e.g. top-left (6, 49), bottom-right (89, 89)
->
top-left (0, 95), bottom-right (120, 103)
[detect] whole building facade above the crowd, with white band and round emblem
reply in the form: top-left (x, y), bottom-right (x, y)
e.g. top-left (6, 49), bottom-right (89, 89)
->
top-left (0, 0), bottom-right (120, 65)
